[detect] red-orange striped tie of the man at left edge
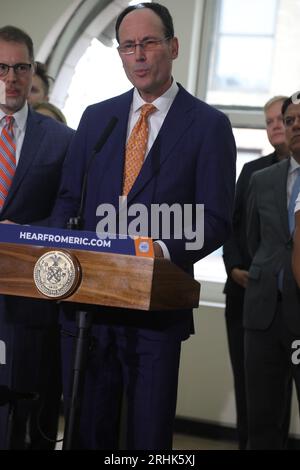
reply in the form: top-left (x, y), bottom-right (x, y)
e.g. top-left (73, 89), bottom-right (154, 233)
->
top-left (0, 116), bottom-right (16, 210)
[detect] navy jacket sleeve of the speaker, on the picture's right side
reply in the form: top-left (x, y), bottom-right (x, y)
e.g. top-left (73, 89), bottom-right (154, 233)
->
top-left (165, 113), bottom-right (236, 265)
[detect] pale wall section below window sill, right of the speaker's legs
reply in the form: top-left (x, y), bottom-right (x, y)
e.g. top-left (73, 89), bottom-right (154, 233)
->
top-left (177, 306), bottom-right (235, 426)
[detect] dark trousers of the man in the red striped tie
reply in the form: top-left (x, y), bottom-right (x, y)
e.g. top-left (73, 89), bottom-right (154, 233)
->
top-left (0, 325), bottom-right (62, 450)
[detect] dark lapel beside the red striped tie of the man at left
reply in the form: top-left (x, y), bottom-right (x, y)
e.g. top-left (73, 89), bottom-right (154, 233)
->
top-left (3, 109), bottom-right (45, 209)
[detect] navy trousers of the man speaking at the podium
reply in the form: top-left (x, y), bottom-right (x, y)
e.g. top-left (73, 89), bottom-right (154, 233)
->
top-left (62, 324), bottom-right (181, 450)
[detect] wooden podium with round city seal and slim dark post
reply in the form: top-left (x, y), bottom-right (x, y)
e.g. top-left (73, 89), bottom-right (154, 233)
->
top-left (0, 229), bottom-right (200, 450)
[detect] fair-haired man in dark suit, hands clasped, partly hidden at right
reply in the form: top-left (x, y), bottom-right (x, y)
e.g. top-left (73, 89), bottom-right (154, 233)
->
top-left (223, 96), bottom-right (290, 450)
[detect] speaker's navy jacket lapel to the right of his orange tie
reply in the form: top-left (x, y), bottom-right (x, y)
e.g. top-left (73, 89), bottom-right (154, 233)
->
top-left (127, 87), bottom-right (194, 203)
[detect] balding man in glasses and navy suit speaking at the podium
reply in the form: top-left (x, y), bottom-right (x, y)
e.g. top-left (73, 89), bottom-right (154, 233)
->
top-left (49, 3), bottom-right (236, 450)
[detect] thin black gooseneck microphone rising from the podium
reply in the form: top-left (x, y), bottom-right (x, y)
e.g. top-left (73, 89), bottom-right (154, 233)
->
top-left (67, 116), bottom-right (118, 230)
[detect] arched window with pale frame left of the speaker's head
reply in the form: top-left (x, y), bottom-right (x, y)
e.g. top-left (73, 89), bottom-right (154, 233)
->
top-left (39, 0), bottom-right (151, 129)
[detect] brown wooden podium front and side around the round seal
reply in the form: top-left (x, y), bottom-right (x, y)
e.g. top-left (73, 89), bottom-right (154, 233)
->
top-left (0, 243), bottom-right (200, 310)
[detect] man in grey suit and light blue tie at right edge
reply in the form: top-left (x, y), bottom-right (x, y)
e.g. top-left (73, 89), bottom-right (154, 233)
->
top-left (244, 94), bottom-right (300, 449)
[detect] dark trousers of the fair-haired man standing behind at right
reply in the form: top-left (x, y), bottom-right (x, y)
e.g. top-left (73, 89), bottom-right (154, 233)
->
top-left (225, 291), bottom-right (292, 450)
